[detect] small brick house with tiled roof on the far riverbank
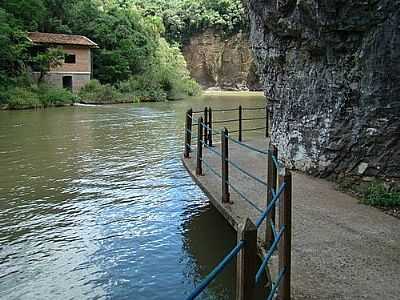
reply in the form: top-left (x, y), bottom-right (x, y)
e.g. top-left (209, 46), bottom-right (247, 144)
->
top-left (28, 32), bottom-right (98, 92)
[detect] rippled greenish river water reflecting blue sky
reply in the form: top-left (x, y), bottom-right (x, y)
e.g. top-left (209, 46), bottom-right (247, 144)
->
top-left (0, 95), bottom-right (264, 300)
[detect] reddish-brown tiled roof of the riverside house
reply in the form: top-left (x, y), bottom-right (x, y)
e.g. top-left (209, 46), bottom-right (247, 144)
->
top-left (28, 32), bottom-right (98, 48)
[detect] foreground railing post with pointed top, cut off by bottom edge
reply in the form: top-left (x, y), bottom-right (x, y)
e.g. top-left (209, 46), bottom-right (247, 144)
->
top-left (236, 218), bottom-right (257, 300)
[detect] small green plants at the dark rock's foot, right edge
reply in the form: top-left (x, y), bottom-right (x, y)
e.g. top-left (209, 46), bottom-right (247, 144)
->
top-left (364, 183), bottom-right (400, 207)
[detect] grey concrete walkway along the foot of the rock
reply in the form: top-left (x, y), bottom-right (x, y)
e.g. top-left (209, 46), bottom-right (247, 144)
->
top-left (183, 139), bottom-right (400, 299)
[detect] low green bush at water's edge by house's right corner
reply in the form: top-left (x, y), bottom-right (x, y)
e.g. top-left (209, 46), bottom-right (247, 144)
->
top-left (79, 80), bottom-right (128, 104)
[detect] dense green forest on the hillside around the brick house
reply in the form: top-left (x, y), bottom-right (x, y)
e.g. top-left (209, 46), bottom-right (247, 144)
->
top-left (0, 0), bottom-right (247, 108)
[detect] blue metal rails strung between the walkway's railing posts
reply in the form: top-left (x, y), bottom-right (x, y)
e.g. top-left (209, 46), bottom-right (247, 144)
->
top-left (186, 107), bottom-right (287, 300)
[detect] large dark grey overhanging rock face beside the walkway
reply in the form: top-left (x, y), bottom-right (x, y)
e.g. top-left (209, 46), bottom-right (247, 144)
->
top-left (248, 0), bottom-right (400, 179)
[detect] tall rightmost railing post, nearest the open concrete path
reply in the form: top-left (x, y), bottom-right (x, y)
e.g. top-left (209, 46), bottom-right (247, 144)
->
top-left (279, 171), bottom-right (292, 300)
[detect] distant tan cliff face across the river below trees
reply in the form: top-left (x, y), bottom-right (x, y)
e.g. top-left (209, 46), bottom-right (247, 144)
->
top-left (183, 30), bottom-right (261, 90)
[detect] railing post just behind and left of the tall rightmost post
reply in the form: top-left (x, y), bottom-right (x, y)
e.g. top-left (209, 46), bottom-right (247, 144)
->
top-left (265, 142), bottom-right (278, 249)
